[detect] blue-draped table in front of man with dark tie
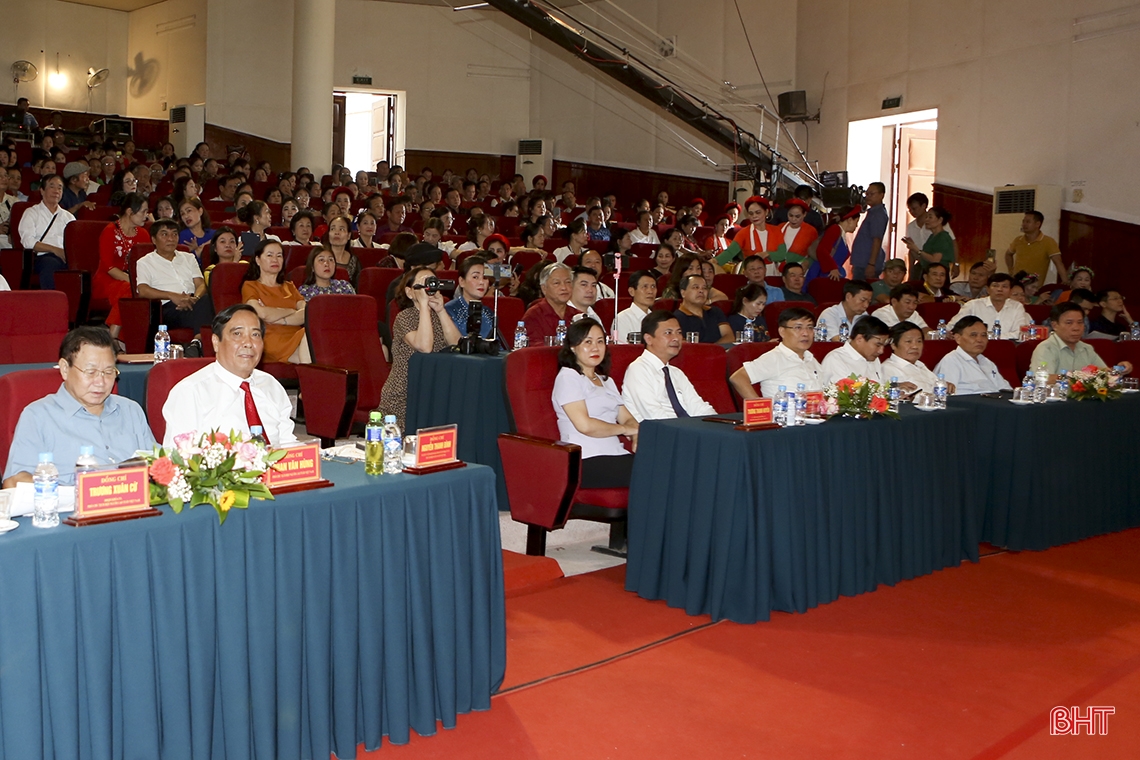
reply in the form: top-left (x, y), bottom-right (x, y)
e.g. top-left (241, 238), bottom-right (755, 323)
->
top-left (626, 408), bottom-right (979, 623)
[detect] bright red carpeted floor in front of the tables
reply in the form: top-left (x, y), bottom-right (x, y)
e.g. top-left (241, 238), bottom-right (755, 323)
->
top-left (359, 530), bottom-right (1140, 760)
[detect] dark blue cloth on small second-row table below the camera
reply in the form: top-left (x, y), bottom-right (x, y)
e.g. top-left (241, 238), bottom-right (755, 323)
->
top-left (407, 353), bottom-right (511, 510)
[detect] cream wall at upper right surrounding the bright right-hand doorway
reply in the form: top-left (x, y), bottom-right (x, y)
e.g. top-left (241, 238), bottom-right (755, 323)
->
top-left (796, 0), bottom-right (1140, 221)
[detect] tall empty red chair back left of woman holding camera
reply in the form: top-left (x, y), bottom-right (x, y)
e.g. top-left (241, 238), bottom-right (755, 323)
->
top-left (304, 295), bottom-right (390, 414)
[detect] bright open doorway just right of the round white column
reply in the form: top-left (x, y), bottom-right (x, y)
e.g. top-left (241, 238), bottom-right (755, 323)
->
top-left (333, 91), bottom-right (398, 180)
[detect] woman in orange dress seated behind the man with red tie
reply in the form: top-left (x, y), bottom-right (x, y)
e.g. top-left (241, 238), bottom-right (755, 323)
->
top-left (242, 240), bottom-right (312, 365)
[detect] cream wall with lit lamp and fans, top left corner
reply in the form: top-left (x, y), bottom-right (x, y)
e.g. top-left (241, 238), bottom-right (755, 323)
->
top-left (0, 0), bottom-right (127, 114)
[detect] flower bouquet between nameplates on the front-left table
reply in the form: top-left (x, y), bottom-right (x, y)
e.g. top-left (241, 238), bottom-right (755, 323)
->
top-left (145, 430), bottom-right (285, 524)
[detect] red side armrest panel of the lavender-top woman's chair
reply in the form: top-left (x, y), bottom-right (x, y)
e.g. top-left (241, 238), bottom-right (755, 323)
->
top-left (498, 433), bottom-right (581, 530)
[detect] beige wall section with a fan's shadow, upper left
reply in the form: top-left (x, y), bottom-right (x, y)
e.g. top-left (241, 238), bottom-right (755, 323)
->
top-left (127, 0), bottom-right (206, 119)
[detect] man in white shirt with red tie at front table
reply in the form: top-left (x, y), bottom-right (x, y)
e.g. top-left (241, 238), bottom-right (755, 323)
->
top-left (162, 303), bottom-right (296, 447)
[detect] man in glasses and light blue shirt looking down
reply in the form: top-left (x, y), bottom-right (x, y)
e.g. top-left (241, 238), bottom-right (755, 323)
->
top-left (3, 327), bottom-right (155, 488)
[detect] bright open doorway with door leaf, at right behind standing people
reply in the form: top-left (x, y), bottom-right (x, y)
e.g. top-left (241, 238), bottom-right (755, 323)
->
top-left (847, 108), bottom-right (938, 268)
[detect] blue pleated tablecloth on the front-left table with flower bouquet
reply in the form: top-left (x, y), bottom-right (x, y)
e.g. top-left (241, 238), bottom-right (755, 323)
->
top-left (0, 463), bottom-right (506, 760)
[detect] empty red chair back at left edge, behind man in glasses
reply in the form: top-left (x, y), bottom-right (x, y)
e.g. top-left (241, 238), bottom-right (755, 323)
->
top-left (0, 291), bottom-right (67, 365)
